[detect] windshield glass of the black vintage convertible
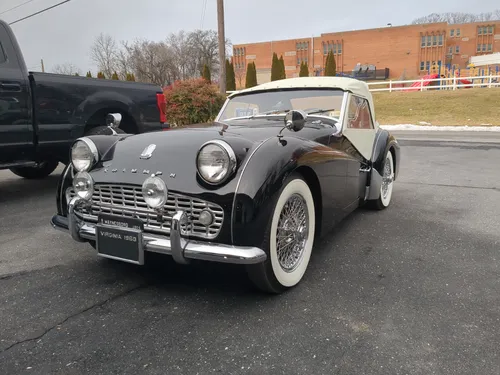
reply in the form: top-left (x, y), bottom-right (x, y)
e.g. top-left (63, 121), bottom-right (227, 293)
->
top-left (219, 89), bottom-right (344, 121)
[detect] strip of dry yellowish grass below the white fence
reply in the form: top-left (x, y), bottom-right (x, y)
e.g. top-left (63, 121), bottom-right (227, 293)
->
top-left (372, 88), bottom-right (500, 126)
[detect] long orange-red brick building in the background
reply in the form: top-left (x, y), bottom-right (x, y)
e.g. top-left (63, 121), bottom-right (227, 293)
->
top-left (233, 21), bottom-right (500, 87)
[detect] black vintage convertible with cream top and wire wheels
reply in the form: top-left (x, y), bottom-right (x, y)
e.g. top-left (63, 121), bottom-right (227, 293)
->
top-left (52, 77), bottom-right (400, 293)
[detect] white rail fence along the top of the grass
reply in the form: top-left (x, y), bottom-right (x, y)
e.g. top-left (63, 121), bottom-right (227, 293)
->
top-left (227, 75), bottom-right (500, 94)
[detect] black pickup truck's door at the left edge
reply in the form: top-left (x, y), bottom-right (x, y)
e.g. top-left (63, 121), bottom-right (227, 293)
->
top-left (0, 24), bottom-right (33, 163)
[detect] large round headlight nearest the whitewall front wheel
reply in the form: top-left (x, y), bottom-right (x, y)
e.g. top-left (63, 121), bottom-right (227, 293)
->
top-left (196, 141), bottom-right (236, 184)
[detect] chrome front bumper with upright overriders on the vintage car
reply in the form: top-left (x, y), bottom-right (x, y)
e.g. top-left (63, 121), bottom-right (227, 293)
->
top-left (51, 197), bottom-right (267, 264)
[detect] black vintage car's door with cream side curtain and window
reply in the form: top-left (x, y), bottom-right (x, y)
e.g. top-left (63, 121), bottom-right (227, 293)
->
top-left (342, 94), bottom-right (377, 206)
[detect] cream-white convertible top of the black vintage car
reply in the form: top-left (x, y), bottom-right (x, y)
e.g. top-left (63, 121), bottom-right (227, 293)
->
top-left (228, 77), bottom-right (375, 119)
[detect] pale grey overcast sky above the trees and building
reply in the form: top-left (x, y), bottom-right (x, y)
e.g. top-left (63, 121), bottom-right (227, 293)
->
top-left (0, 0), bottom-right (498, 72)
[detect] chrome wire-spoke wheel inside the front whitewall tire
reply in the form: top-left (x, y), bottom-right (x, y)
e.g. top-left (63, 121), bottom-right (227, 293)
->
top-left (276, 194), bottom-right (309, 272)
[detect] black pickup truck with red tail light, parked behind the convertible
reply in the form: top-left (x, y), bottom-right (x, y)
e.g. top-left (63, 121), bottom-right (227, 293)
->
top-left (0, 20), bottom-right (169, 178)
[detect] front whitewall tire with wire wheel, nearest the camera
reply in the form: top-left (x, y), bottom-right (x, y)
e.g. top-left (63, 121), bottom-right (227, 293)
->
top-left (247, 176), bottom-right (316, 293)
